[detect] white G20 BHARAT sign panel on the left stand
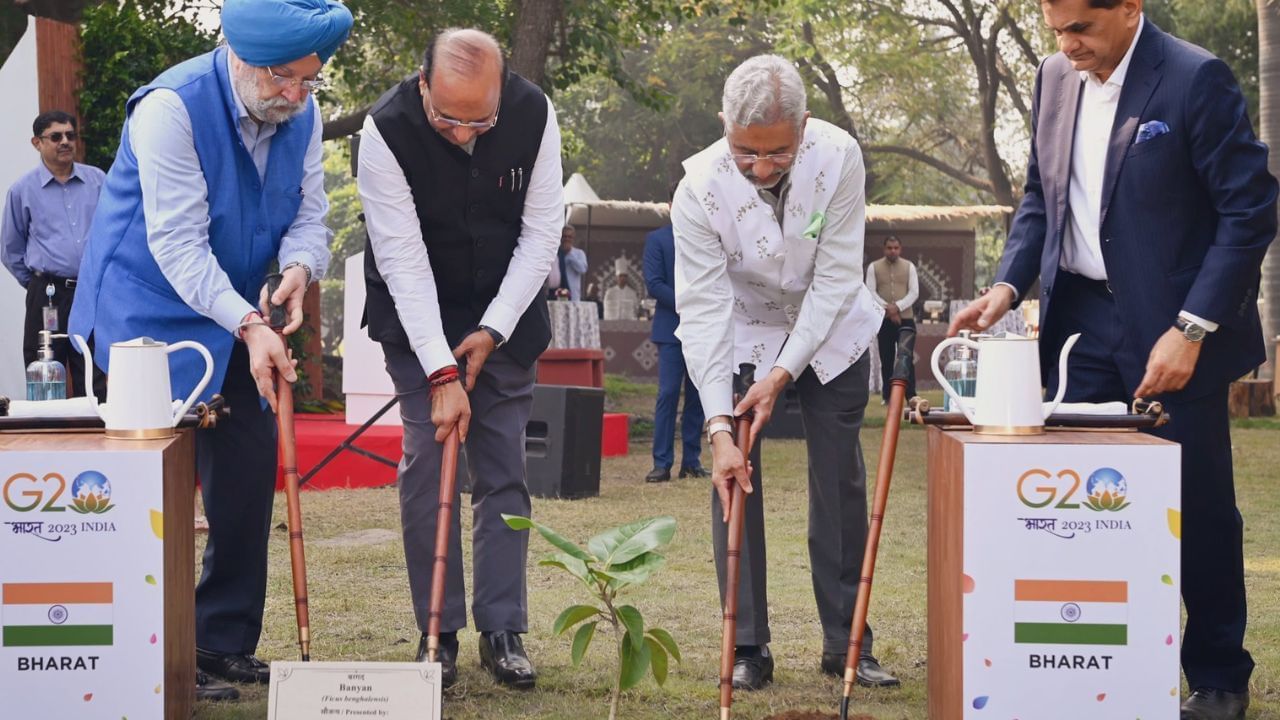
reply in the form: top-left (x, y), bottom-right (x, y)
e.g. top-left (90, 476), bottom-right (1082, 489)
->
top-left (0, 451), bottom-right (164, 720)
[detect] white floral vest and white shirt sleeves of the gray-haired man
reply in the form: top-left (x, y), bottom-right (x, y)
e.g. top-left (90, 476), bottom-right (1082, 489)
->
top-left (672, 118), bottom-right (884, 418)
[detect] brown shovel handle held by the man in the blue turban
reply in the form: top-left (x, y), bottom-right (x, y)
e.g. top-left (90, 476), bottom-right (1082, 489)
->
top-left (266, 273), bottom-right (311, 661)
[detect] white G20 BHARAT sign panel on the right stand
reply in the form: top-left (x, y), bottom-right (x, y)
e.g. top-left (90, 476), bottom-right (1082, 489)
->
top-left (964, 443), bottom-right (1181, 719)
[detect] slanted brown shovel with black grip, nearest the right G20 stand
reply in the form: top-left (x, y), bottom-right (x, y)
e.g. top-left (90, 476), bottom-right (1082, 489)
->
top-left (840, 327), bottom-right (915, 720)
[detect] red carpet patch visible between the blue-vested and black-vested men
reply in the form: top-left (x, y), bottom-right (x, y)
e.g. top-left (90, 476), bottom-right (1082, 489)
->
top-left (275, 414), bottom-right (401, 491)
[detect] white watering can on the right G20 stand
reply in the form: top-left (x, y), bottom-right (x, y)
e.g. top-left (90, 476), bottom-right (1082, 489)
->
top-left (933, 333), bottom-right (1080, 436)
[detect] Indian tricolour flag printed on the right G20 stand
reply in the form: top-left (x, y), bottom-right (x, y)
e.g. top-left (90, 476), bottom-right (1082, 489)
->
top-left (1014, 580), bottom-right (1129, 644)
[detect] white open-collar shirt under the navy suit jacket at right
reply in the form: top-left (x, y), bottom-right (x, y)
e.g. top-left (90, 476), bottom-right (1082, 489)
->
top-left (1059, 17), bottom-right (1147, 281)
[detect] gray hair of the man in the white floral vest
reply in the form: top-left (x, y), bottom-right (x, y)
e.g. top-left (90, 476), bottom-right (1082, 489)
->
top-left (721, 55), bottom-right (805, 127)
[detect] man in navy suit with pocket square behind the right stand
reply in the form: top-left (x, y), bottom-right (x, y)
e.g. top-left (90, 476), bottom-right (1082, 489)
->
top-left (951, 0), bottom-right (1276, 720)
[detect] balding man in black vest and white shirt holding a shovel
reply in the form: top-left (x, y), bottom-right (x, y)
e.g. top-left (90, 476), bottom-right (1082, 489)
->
top-left (357, 29), bottom-right (564, 688)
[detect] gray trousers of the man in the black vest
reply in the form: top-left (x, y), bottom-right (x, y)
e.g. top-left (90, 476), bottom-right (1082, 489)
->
top-left (383, 343), bottom-right (534, 633)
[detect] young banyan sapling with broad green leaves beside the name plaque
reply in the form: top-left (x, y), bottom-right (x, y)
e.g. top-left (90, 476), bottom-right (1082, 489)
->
top-left (502, 515), bottom-right (680, 720)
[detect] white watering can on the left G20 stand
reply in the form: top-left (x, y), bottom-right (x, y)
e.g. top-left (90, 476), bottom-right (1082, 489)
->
top-left (74, 336), bottom-right (214, 439)
